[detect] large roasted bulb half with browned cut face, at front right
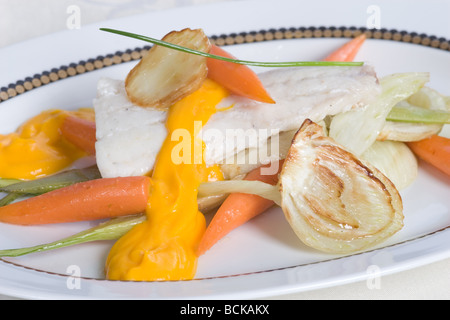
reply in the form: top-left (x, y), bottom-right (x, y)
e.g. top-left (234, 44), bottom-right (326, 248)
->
top-left (279, 120), bottom-right (403, 254)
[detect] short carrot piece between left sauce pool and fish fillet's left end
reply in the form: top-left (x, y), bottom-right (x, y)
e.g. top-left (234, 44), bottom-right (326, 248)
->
top-left (61, 116), bottom-right (97, 155)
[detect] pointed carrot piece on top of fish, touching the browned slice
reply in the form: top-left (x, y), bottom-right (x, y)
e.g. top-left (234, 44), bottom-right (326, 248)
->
top-left (208, 45), bottom-right (275, 104)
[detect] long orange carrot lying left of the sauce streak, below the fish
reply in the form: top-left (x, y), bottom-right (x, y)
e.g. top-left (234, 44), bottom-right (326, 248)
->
top-left (0, 177), bottom-right (150, 225)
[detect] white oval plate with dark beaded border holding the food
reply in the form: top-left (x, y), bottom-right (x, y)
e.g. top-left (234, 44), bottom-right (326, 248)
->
top-left (0, 1), bottom-right (450, 299)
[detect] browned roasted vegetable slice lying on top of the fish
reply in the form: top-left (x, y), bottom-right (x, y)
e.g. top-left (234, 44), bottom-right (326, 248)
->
top-left (125, 29), bottom-right (211, 109)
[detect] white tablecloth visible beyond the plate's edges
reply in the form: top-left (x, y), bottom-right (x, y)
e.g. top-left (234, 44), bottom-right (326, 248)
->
top-left (0, 0), bottom-right (450, 300)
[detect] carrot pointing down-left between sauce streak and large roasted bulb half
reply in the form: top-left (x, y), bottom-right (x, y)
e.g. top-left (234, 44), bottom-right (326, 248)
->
top-left (196, 161), bottom-right (283, 256)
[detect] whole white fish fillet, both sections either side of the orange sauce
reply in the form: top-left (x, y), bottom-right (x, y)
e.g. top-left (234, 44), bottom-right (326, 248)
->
top-left (94, 66), bottom-right (381, 177)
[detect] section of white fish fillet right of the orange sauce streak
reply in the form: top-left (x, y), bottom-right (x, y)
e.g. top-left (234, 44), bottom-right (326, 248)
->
top-left (203, 66), bottom-right (381, 163)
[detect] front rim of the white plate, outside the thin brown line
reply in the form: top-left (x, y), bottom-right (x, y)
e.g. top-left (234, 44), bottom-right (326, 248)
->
top-left (0, 227), bottom-right (450, 300)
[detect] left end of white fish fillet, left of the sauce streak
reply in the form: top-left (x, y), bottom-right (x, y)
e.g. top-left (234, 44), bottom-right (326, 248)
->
top-left (94, 78), bottom-right (167, 178)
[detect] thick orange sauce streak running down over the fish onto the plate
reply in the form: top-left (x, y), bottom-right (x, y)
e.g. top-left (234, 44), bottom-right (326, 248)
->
top-left (106, 80), bottom-right (228, 281)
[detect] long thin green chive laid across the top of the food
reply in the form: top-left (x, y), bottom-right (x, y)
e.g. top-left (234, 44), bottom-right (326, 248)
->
top-left (100, 28), bottom-right (364, 68)
